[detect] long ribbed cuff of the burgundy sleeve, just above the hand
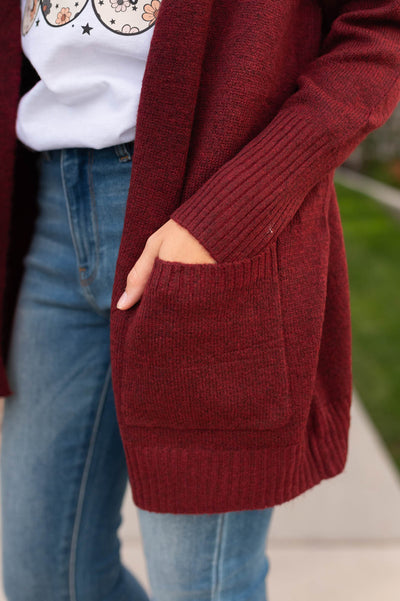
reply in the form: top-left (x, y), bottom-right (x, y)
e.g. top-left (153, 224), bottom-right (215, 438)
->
top-left (171, 105), bottom-right (365, 262)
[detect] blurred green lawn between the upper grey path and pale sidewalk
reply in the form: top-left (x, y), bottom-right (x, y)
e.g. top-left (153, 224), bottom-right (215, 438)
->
top-left (335, 182), bottom-right (400, 470)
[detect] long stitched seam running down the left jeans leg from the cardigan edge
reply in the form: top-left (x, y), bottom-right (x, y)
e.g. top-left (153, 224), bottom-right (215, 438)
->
top-left (68, 364), bottom-right (111, 601)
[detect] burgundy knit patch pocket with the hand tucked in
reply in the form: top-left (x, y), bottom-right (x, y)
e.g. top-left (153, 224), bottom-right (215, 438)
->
top-left (120, 242), bottom-right (292, 430)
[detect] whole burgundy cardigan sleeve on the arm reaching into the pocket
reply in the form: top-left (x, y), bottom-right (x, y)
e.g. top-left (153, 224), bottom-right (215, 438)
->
top-left (170, 0), bottom-right (400, 262)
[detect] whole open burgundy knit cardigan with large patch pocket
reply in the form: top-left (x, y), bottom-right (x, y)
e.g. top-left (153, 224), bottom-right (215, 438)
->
top-left (0, 0), bottom-right (400, 513)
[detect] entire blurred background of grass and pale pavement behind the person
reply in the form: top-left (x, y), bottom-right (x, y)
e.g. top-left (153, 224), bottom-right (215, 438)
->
top-left (0, 111), bottom-right (400, 601)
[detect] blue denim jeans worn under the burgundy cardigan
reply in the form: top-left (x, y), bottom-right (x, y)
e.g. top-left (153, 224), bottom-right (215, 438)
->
top-left (1, 144), bottom-right (273, 601)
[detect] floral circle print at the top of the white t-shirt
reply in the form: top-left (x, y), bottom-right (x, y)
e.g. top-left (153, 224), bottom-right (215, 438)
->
top-left (22, 0), bottom-right (161, 35)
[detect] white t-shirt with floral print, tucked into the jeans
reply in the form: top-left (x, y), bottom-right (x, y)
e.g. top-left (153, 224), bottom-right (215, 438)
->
top-left (16, 0), bottom-right (160, 151)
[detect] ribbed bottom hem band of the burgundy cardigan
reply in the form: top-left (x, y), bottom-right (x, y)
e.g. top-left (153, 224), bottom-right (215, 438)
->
top-left (124, 404), bottom-right (349, 514)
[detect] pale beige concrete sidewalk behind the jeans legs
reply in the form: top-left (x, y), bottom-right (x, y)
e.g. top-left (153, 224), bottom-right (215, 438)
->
top-left (0, 386), bottom-right (400, 601)
